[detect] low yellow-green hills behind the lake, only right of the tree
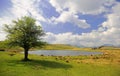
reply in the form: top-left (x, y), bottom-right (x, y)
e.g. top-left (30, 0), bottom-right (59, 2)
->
top-left (31, 44), bottom-right (120, 51)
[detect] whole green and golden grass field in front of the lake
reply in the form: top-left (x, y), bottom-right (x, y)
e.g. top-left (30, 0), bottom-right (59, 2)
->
top-left (0, 45), bottom-right (120, 76)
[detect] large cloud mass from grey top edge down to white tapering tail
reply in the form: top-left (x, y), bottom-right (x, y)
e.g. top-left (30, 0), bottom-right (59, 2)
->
top-left (50, 0), bottom-right (115, 28)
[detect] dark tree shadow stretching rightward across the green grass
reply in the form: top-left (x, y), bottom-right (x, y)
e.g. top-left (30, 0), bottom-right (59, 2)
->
top-left (7, 60), bottom-right (72, 69)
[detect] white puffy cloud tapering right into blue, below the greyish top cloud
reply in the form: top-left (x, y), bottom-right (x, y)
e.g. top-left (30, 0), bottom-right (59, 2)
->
top-left (52, 11), bottom-right (90, 28)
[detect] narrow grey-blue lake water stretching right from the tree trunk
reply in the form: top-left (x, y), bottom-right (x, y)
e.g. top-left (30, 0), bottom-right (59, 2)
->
top-left (29, 50), bottom-right (103, 56)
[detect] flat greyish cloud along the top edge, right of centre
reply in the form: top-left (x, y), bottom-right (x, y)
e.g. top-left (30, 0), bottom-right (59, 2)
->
top-left (50, 0), bottom-right (115, 14)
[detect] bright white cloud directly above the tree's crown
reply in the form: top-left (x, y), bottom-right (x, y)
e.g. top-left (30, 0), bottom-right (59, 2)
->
top-left (10, 0), bottom-right (45, 21)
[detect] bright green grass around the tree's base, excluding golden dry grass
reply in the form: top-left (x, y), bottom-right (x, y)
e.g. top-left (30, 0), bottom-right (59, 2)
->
top-left (0, 52), bottom-right (120, 76)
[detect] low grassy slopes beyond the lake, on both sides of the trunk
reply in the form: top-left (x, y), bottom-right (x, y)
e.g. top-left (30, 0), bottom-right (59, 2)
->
top-left (0, 43), bottom-right (120, 51)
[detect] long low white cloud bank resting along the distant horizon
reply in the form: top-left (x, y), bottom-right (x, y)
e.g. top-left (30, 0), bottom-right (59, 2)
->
top-left (44, 27), bottom-right (120, 47)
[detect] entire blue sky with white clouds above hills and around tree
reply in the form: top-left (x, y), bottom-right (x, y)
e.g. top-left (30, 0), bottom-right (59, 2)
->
top-left (0, 0), bottom-right (120, 47)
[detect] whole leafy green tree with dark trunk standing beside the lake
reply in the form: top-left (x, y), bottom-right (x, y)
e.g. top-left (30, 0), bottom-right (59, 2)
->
top-left (5, 16), bottom-right (45, 61)
